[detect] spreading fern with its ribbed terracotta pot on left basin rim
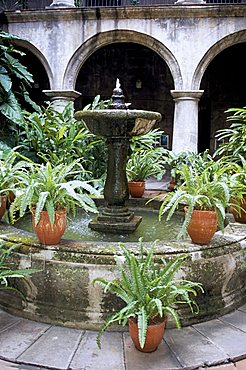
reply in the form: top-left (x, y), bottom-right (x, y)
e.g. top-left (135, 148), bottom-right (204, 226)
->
top-left (10, 161), bottom-right (99, 244)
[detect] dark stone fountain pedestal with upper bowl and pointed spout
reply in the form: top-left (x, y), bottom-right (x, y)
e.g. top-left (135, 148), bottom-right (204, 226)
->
top-left (75, 79), bottom-right (161, 234)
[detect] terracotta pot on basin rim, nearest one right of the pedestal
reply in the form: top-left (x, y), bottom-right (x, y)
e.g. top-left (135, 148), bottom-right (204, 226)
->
top-left (185, 210), bottom-right (218, 245)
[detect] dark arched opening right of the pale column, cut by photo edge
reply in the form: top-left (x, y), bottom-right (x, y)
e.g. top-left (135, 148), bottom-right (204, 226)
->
top-left (198, 42), bottom-right (246, 153)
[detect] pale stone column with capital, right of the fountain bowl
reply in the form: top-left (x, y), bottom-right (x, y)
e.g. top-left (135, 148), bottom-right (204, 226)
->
top-left (171, 90), bottom-right (204, 153)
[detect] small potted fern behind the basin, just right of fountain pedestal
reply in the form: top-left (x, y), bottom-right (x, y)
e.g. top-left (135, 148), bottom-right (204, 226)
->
top-left (126, 148), bottom-right (165, 198)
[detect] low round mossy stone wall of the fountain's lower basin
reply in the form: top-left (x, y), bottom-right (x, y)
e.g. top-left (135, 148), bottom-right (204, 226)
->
top-left (0, 204), bottom-right (246, 329)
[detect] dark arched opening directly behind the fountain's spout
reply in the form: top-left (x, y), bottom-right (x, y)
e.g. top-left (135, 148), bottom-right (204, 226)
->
top-left (75, 42), bottom-right (174, 148)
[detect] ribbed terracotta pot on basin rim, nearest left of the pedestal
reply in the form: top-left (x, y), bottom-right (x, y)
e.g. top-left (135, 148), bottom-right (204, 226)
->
top-left (32, 209), bottom-right (67, 245)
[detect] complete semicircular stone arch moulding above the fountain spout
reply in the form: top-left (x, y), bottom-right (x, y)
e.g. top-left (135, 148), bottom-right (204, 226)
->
top-left (63, 30), bottom-right (183, 89)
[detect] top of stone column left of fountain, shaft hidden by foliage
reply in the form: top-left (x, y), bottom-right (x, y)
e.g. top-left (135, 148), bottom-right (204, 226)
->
top-left (43, 90), bottom-right (81, 112)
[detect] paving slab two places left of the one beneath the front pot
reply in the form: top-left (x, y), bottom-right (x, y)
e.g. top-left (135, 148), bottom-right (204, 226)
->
top-left (17, 326), bottom-right (83, 370)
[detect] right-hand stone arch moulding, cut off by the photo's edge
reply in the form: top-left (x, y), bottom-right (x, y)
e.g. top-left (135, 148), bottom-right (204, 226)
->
top-left (192, 30), bottom-right (246, 90)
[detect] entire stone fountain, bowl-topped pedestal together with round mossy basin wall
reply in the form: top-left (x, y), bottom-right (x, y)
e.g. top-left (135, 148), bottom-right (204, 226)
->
top-left (0, 81), bottom-right (243, 329)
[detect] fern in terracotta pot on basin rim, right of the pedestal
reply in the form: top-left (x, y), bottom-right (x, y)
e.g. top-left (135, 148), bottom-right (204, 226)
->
top-left (159, 162), bottom-right (230, 245)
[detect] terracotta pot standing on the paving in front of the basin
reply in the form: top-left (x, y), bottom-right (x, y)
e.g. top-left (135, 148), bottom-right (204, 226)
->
top-left (128, 318), bottom-right (167, 352)
